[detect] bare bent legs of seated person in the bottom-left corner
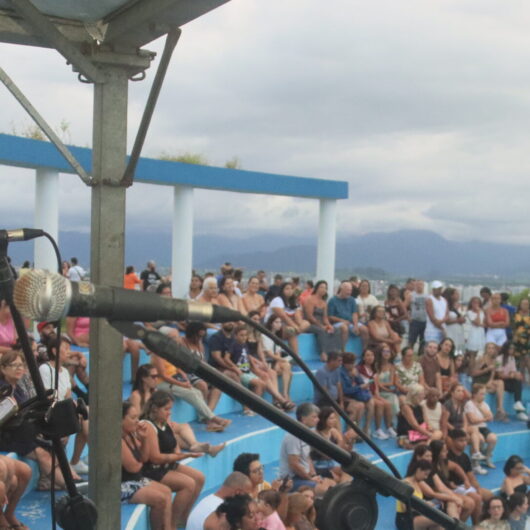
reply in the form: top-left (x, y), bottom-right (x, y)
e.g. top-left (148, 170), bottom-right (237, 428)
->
top-left (0, 455), bottom-right (31, 530)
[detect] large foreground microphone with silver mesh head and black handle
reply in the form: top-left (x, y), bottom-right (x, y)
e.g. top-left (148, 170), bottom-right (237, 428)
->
top-left (13, 270), bottom-right (242, 322)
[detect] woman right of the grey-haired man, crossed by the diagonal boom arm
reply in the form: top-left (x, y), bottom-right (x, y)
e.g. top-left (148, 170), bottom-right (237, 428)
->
top-left (310, 407), bottom-right (353, 484)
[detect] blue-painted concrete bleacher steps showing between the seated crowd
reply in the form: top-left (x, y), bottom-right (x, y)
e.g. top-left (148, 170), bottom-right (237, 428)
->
top-left (8, 335), bottom-right (530, 530)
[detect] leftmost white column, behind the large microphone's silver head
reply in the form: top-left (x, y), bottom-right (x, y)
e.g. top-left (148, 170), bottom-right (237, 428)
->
top-left (34, 168), bottom-right (59, 272)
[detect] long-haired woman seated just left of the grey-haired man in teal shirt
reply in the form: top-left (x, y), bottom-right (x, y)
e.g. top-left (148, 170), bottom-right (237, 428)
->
top-left (303, 280), bottom-right (342, 362)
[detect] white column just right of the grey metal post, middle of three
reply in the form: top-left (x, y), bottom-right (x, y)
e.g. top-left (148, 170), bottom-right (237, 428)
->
top-left (171, 186), bottom-right (193, 298)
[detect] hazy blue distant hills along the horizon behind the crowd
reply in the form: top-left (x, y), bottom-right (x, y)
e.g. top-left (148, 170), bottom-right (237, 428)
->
top-left (9, 230), bottom-right (530, 278)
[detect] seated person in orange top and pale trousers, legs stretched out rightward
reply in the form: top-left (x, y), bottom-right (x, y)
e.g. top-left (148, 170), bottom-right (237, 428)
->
top-left (152, 354), bottom-right (231, 432)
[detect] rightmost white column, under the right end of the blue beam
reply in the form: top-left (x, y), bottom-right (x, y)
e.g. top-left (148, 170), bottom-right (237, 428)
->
top-left (316, 199), bottom-right (337, 293)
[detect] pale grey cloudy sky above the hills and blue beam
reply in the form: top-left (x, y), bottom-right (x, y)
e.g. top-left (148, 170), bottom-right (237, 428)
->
top-left (0, 0), bottom-right (530, 244)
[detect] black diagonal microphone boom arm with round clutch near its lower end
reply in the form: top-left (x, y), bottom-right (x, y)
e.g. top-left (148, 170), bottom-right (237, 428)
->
top-left (110, 321), bottom-right (469, 530)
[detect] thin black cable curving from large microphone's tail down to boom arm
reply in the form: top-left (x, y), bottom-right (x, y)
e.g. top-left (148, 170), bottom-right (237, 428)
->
top-left (236, 314), bottom-right (402, 479)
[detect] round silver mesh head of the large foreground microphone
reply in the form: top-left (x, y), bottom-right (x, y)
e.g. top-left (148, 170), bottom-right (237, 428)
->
top-left (13, 269), bottom-right (71, 321)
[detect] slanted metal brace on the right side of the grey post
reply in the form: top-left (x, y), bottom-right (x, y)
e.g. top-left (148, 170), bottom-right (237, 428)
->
top-left (121, 28), bottom-right (182, 186)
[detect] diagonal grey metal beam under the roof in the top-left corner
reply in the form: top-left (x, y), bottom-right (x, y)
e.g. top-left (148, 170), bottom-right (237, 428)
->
top-left (8, 0), bottom-right (105, 83)
